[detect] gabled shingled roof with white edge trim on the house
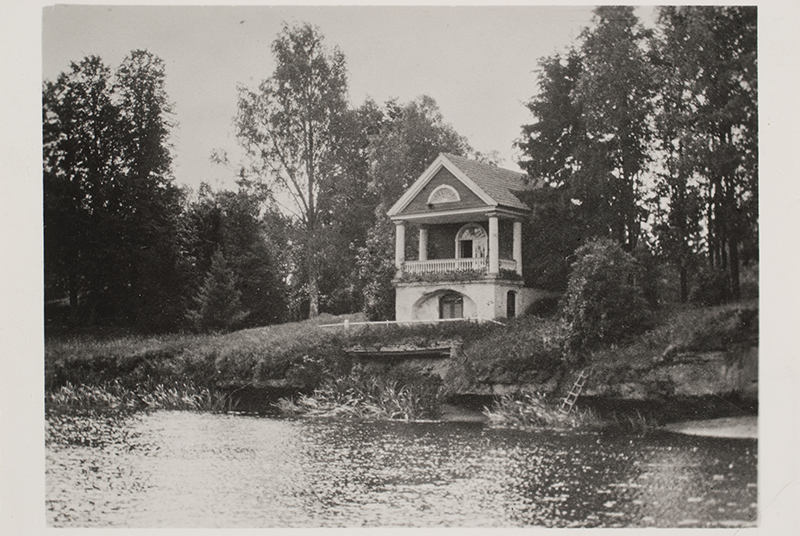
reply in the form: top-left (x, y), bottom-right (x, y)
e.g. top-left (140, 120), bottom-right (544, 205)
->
top-left (388, 153), bottom-right (535, 217)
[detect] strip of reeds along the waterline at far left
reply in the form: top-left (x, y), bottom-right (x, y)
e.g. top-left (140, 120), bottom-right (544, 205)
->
top-left (45, 380), bottom-right (226, 411)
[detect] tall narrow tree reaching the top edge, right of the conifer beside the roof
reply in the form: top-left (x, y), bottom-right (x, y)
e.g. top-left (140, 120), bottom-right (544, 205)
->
top-left (574, 6), bottom-right (655, 251)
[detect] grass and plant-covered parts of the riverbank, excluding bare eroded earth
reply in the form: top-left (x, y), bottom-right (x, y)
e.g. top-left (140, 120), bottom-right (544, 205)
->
top-left (45, 300), bottom-right (758, 426)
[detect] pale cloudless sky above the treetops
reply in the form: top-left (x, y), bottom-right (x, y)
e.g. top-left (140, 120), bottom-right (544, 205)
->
top-left (42, 5), bottom-right (653, 189)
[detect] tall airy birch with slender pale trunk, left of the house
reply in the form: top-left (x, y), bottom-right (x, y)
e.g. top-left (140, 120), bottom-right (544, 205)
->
top-left (235, 23), bottom-right (347, 317)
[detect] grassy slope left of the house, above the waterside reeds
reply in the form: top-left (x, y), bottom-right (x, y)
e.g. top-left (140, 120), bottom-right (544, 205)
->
top-left (45, 317), bottom-right (364, 392)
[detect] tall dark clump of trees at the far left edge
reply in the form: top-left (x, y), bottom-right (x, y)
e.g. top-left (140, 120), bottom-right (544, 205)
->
top-left (42, 51), bottom-right (184, 329)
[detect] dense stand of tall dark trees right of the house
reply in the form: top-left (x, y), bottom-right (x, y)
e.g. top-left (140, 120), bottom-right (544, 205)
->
top-left (517, 6), bottom-right (758, 302)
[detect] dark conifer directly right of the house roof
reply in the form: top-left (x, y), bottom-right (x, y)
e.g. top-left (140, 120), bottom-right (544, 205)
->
top-left (515, 49), bottom-right (596, 290)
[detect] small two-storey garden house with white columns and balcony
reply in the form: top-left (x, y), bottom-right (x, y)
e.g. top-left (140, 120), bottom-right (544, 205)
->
top-left (388, 154), bottom-right (538, 322)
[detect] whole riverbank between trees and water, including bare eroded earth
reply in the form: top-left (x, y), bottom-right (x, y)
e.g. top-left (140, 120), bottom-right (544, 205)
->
top-left (45, 300), bottom-right (758, 425)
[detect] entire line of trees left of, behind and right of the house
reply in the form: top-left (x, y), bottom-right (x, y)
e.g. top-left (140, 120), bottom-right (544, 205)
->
top-left (43, 7), bottom-right (758, 331)
